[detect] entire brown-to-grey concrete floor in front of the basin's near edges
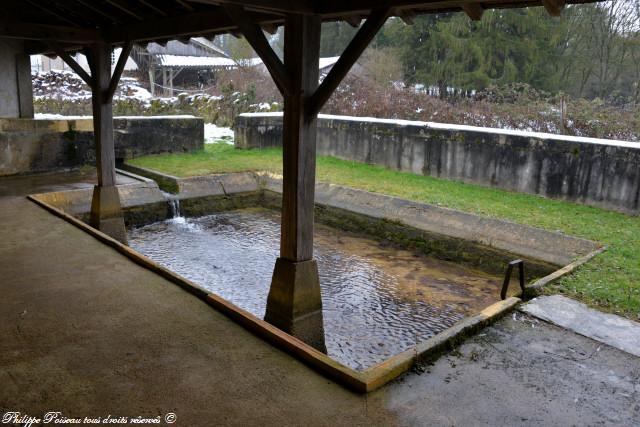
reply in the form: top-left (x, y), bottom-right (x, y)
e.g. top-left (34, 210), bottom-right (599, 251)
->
top-left (0, 173), bottom-right (640, 426)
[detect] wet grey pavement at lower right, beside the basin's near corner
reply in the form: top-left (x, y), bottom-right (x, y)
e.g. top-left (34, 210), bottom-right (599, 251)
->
top-left (378, 312), bottom-right (640, 426)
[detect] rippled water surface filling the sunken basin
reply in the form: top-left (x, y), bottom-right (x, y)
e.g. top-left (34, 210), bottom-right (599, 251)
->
top-left (128, 209), bottom-right (500, 370)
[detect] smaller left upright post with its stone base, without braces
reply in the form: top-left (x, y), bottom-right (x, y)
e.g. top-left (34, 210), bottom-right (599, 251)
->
top-left (89, 44), bottom-right (126, 243)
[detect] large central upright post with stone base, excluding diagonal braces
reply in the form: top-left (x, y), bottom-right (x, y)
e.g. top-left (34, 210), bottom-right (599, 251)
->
top-left (265, 15), bottom-right (326, 351)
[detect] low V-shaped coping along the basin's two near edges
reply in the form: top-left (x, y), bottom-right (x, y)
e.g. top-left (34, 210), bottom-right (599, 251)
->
top-left (27, 196), bottom-right (521, 393)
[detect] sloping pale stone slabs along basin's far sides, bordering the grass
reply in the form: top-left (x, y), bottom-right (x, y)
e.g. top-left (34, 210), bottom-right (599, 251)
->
top-left (121, 167), bottom-right (602, 266)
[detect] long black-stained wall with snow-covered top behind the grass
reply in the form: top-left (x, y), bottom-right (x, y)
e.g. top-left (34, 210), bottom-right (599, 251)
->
top-left (234, 113), bottom-right (640, 213)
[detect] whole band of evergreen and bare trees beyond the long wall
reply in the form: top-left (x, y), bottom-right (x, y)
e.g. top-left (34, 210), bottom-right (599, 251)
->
top-left (374, 0), bottom-right (640, 105)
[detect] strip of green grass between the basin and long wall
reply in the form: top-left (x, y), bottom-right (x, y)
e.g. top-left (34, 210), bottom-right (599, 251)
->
top-left (130, 144), bottom-right (640, 320)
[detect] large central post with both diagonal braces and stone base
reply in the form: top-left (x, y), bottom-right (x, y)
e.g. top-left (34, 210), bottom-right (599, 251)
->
top-left (230, 5), bottom-right (390, 351)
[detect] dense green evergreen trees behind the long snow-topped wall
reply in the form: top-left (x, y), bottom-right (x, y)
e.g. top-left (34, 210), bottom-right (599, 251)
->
top-left (378, 8), bottom-right (565, 91)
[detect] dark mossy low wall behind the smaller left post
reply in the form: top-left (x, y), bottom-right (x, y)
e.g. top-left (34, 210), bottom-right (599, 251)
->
top-left (0, 116), bottom-right (204, 176)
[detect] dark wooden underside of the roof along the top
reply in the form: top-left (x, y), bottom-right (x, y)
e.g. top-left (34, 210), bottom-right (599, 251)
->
top-left (0, 0), bottom-right (592, 53)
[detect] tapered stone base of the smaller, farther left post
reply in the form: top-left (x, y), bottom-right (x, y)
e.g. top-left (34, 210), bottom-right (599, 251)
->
top-left (89, 185), bottom-right (127, 244)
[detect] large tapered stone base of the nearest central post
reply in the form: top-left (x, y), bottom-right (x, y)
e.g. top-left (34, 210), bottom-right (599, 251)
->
top-left (264, 258), bottom-right (327, 353)
